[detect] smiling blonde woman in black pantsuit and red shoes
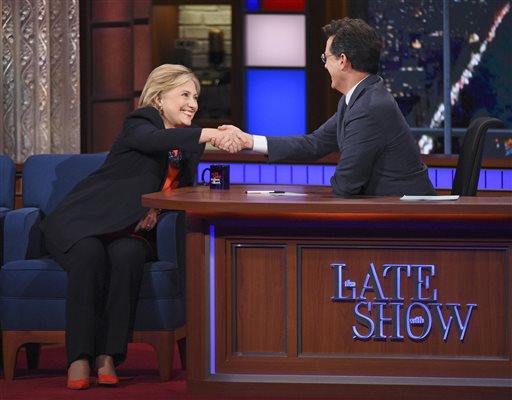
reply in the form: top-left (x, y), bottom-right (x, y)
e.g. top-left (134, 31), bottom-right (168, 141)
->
top-left (41, 64), bottom-right (239, 389)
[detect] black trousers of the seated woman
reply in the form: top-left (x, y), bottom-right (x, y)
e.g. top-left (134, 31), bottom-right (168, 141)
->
top-left (47, 237), bottom-right (154, 365)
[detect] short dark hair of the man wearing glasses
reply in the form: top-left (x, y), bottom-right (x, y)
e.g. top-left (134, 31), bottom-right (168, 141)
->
top-left (322, 17), bottom-right (382, 74)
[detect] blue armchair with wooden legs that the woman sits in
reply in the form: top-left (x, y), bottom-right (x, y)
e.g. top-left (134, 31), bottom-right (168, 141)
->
top-left (0, 154), bottom-right (185, 380)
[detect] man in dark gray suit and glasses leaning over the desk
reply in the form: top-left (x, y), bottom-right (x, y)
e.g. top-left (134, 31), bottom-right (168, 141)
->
top-left (213, 18), bottom-right (436, 196)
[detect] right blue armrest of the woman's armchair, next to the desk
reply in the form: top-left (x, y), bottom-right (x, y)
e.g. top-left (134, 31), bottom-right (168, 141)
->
top-left (156, 211), bottom-right (185, 268)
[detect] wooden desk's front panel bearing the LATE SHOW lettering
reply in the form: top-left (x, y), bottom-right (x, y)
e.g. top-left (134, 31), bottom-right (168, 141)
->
top-left (210, 222), bottom-right (512, 379)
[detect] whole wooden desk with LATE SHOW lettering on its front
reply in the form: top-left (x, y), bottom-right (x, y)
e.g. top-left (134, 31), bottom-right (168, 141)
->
top-left (143, 185), bottom-right (512, 399)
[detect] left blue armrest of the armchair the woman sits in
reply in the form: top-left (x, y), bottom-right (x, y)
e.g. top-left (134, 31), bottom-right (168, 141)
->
top-left (4, 207), bottom-right (42, 263)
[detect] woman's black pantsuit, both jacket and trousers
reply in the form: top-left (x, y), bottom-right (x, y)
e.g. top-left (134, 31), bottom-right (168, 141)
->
top-left (40, 107), bottom-right (205, 365)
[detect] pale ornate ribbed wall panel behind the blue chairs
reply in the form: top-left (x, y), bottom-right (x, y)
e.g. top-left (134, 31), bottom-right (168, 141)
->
top-left (0, 0), bottom-right (80, 163)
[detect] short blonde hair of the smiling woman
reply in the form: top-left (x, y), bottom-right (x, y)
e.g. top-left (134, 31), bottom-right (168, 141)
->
top-left (139, 64), bottom-right (201, 109)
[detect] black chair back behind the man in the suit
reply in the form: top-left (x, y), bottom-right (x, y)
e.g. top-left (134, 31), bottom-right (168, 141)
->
top-left (452, 117), bottom-right (503, 196)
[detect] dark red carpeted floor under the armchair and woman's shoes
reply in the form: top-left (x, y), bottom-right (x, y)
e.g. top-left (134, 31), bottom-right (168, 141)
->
top-left (0, 344), bottom-right (348, 400)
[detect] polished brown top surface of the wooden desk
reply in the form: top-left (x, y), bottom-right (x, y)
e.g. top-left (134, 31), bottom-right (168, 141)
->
top-left (142, 185), bottom-right (512, 221)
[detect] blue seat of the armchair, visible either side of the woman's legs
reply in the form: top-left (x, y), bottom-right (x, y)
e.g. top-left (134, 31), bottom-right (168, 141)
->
top-left (0, 258), bottom-right (185, 330)
